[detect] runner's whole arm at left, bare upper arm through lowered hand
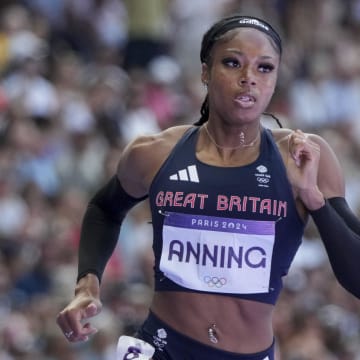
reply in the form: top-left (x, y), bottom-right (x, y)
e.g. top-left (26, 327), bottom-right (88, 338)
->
top-left (57, 134), bottom-right (160, 342)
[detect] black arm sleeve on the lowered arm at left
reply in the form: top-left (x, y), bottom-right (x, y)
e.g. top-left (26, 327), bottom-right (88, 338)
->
top-left (77, 176), bottom-right (147, 281)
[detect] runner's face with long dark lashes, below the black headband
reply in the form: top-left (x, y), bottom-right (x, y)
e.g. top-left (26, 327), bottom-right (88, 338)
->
top-left (202, 28), bottom-right (280, 124)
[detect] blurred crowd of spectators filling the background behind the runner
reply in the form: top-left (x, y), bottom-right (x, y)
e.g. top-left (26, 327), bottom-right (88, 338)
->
top-left (0, 0), bottom-right (360, 360)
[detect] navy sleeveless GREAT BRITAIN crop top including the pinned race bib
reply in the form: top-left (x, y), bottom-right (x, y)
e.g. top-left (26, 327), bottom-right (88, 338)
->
top-left (149, 127), bottom-right (304, 304)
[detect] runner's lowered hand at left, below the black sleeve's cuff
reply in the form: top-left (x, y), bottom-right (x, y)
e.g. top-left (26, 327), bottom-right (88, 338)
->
top-left (56, 274), bottom-right (102, 342)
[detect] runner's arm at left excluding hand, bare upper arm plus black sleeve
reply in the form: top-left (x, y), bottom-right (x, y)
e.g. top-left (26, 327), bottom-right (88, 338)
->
top-left (77, 132), bottom-right (167, 282)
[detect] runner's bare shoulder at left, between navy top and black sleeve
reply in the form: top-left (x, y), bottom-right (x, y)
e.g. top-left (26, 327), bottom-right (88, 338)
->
top-left (117, 125), bottom-right (192, 197)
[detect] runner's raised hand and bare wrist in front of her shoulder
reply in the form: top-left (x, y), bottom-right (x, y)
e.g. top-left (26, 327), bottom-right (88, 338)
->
top-left (287, 130), bottom-right (325, 210)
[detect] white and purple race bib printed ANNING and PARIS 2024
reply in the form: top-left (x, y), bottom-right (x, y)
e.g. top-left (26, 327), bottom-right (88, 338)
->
top-left (160, 212), bottom-right (275, 294)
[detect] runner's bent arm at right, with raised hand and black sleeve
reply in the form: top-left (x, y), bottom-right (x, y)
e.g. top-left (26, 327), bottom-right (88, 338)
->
top-left (289, 132), bottom-right (360, 298)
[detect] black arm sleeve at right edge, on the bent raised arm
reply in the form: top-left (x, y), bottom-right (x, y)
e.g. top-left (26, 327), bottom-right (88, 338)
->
top-left (310, 197), bottom-right (360, 298)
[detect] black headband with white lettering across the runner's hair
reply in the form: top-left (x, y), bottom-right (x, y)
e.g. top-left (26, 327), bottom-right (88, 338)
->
top-left (200, 15), bottom-right (282, 62)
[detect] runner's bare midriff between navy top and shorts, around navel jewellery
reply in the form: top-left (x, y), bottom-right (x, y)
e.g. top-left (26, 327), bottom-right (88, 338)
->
top-left (151, 291), bottom-right (274, 354)
